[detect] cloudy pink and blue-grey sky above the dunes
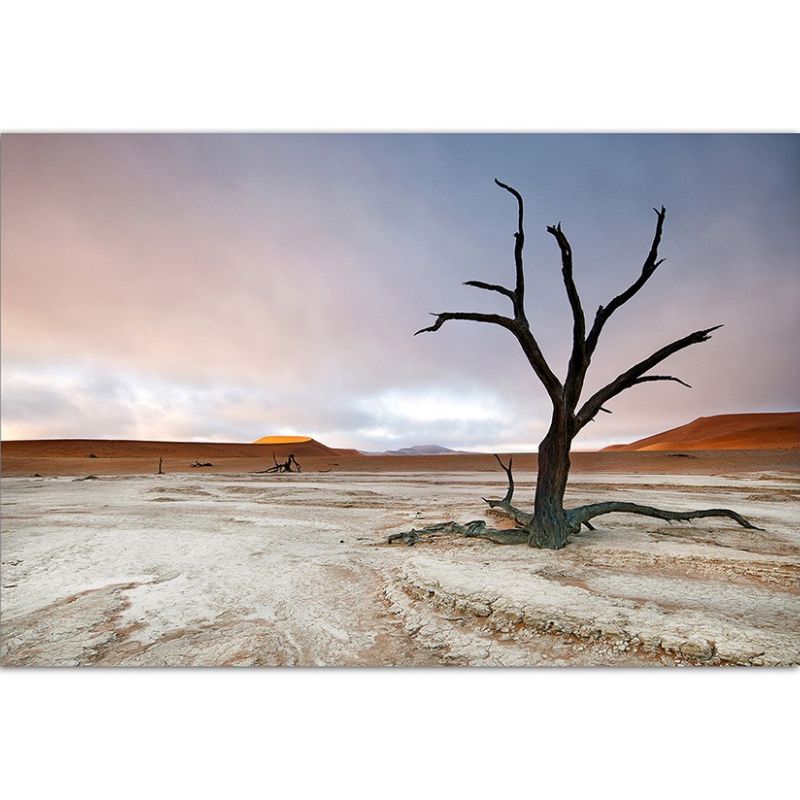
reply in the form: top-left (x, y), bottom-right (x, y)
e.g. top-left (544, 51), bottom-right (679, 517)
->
top-left (0, 134), bottom-right (800, 452)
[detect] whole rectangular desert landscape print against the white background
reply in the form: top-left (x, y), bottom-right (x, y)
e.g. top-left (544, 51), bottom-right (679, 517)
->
top-left (1, 134), bottom-right (800, 666)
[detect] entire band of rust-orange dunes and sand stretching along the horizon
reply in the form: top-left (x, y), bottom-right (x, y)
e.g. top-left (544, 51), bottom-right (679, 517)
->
top-left (0, 411), bottom-right (800, 475)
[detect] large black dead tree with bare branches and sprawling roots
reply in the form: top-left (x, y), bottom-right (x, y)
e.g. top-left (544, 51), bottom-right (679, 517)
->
top-left (394, 180), bottom-right (755, 549)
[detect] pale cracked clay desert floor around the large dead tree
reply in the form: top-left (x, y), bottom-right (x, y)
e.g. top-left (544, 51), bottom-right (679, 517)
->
top-left (2, 460), bottom-right (800, 666)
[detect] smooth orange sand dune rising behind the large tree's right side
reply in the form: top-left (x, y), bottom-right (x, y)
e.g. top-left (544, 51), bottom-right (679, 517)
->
top-left (603, 411), bottom-right (800, 452)
